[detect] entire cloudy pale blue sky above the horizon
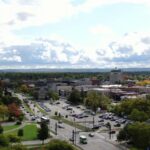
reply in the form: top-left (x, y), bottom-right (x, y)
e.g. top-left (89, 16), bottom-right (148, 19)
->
top-left (0, 0), bottom-right (150, 69)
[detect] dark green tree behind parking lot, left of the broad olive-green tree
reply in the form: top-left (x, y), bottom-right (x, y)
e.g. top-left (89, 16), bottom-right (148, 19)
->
top-left (68, 89), bottom-right (81, 104)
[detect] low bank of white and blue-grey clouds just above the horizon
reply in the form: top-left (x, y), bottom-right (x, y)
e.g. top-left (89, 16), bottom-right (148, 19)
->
top-left (0, 33), bottom-right (150, 68)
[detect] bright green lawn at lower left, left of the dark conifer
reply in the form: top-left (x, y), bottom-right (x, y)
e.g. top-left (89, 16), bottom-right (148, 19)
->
top-left (6, 124), bottom-right (38, 141)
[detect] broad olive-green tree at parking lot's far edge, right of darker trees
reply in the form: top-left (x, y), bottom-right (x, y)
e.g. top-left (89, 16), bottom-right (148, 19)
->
top-left (85, 91), bottom-right (110, 111)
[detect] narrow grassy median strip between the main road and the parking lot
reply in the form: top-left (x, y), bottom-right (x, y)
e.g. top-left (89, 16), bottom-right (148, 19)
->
top-left (51, 116), bottom-right (90, 132)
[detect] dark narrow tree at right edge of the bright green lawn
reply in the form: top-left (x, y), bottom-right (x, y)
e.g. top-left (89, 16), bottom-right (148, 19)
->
top-left (38, 122), bottom-right (49, 144)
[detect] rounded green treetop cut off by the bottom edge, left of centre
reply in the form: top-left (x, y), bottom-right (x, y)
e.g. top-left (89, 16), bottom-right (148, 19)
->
top-left (46, 140), bottom-right (77, 150)
